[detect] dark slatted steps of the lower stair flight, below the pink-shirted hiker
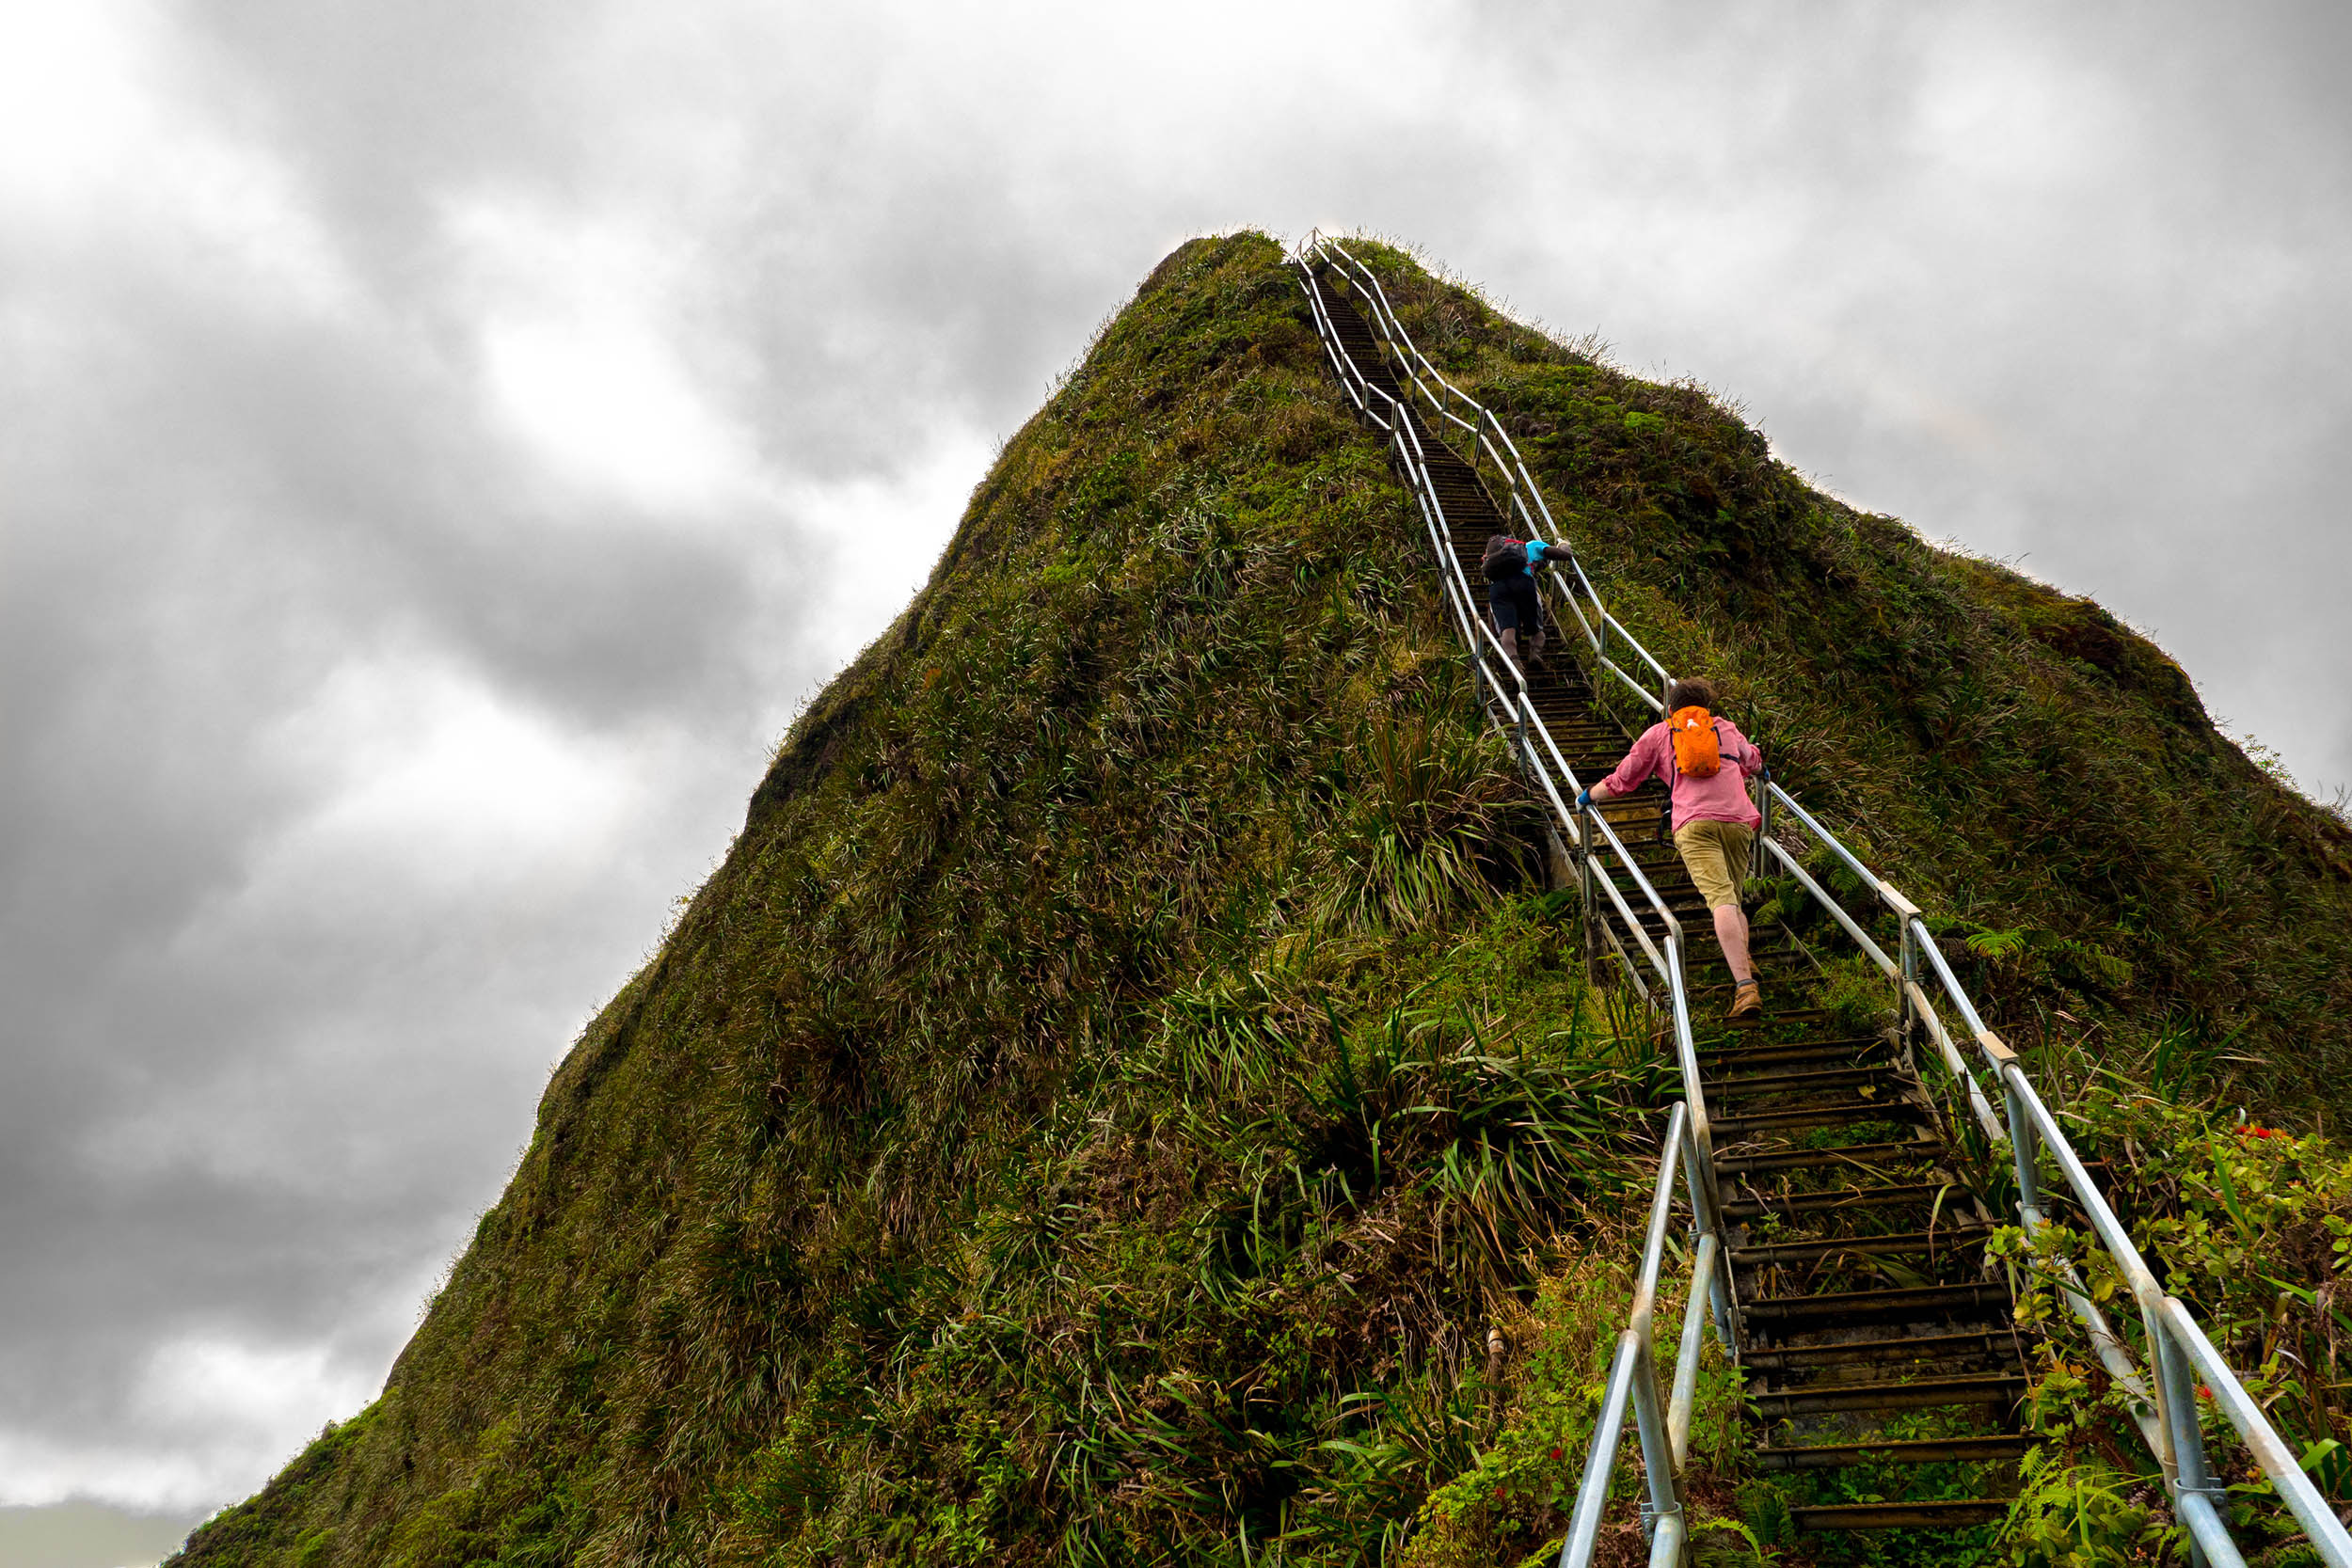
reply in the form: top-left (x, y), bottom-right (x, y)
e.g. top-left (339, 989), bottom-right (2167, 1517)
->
top-left (1701, 1021), bottom-right (2030, 1530)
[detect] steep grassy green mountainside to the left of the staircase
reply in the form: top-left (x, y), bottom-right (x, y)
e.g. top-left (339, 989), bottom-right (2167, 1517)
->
top-left (170, 235), bottom-right (1640, 1566)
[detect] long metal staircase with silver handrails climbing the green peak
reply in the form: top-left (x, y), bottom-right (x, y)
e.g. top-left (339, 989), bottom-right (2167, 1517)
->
top-left (1296, 235), bottom-right (2352, 1568)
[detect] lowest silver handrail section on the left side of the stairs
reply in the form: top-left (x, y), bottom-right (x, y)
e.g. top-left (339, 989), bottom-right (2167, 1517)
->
top-left (1560, 1105), bottom-right (1722, 1568)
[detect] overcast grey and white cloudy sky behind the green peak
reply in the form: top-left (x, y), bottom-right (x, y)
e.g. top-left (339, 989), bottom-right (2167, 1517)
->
top-left (0, 0), bottom-right (2352, 1542)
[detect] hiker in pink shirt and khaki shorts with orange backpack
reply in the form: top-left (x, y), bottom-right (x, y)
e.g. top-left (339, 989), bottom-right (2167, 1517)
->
top-left (1576, 679), bottom-right (1764, 1018)
